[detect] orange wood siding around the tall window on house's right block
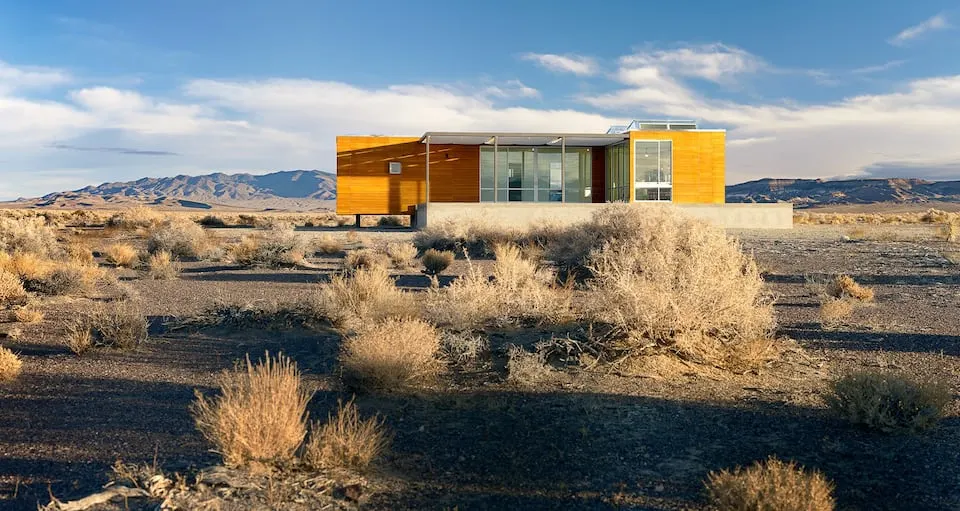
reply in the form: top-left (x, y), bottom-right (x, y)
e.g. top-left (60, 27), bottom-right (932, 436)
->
top-left (630, 131), bottom-right (726, 204)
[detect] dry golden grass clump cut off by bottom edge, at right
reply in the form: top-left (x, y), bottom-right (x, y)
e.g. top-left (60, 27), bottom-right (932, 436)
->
top-left (706, 457), bottom-right (835, 511)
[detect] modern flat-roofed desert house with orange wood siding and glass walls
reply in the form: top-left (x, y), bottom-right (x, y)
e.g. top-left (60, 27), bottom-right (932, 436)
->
top-left (337, 120), bottom-right (792, 225)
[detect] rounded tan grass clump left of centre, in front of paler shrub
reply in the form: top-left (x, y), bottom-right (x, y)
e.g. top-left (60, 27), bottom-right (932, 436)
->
top-left (340, 318), bottom-right (443, 390)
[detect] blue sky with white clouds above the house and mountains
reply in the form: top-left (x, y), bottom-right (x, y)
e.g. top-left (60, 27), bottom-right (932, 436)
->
top-left (0, 0), bottom-right (960, 200)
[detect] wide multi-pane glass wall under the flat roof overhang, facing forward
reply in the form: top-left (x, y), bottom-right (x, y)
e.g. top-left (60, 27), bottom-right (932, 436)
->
top-left (480, 146), bottom-right (591, 202)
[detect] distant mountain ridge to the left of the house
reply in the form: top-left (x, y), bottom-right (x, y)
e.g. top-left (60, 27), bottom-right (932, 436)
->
top-left (21, 170), bottom-right (337, 209)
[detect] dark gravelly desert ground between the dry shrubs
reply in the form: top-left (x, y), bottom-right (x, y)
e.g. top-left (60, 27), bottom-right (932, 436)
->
top-left (0, 206), bottom-right (960, 510)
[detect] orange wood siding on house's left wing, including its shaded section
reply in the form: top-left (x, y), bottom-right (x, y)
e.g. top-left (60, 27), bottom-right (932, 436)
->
top-left (337, 136), bottom-right (480, 215)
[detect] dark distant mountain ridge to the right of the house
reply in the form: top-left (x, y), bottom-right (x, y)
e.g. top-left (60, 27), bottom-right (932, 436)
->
top-left (727, 178), bottom-right (960, 208)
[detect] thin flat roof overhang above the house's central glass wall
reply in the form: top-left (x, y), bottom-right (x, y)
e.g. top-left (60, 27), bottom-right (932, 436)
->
top-left (420, 131), bottom-right (630, 147)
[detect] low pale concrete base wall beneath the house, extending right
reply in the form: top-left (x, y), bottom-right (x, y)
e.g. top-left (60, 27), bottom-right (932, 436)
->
top-left (414, 202), bottom-right (793, 229)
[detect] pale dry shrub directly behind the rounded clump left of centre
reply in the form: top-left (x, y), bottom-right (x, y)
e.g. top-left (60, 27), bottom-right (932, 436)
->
top-left (318, 267), bottom-right (419, 330)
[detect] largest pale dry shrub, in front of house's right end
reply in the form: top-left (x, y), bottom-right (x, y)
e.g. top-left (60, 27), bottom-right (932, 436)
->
top-left (580, 206), bottom-right (774, 367)
